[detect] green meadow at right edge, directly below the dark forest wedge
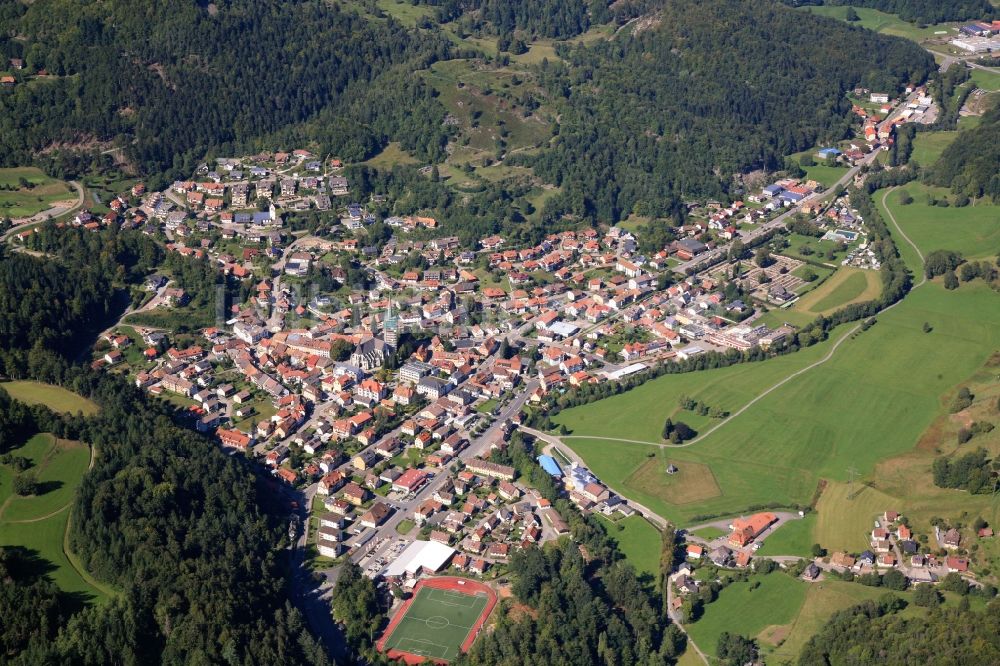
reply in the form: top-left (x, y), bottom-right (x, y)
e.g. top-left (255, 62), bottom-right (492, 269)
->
top-left (875, 183), bottom-right (1000, 268)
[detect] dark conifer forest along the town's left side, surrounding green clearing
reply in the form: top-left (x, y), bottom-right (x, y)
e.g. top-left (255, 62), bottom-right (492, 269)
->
top-left (0, 243), bottom-right (327, 665)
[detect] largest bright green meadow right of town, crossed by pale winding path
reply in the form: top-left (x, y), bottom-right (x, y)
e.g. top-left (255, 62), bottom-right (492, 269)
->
top-left (557, 274), bottom-right (1000, 524)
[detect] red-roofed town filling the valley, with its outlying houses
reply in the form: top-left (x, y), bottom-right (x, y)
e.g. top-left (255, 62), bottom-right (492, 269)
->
top-left (15, 75), bottom-right (992, 657)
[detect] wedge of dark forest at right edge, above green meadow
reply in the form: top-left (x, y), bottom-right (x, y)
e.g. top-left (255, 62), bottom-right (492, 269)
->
top-left (930, 101), bottom-right (1000, 203)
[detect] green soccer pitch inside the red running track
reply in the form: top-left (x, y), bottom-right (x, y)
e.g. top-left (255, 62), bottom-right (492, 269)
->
top-left (384, 587), bottom-right (489, 661)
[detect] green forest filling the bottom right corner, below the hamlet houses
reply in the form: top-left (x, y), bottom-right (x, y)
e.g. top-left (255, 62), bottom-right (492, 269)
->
top-left (798, 586), bottom-right (1000, 666)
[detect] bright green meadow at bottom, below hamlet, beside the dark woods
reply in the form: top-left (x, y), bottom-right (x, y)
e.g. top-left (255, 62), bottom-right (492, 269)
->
top-left (685, 572), bottom-right (808, 655)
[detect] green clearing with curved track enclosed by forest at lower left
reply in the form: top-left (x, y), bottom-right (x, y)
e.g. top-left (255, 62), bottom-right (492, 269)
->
top-left (0, 434), bottom-right (109, 602)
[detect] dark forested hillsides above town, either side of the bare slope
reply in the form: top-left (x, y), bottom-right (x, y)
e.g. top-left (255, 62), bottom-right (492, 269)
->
top-left (0, 0), bottom-right (933, 220)
